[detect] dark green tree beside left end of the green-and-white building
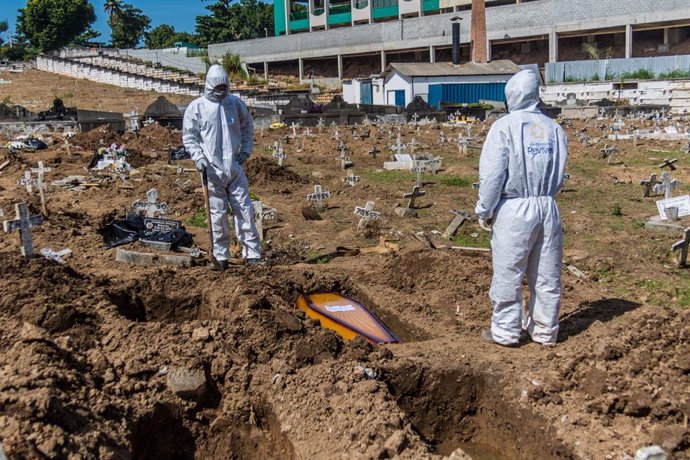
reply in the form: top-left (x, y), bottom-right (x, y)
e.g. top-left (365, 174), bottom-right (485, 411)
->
top-left (196, 0), bottom-right (273, 44)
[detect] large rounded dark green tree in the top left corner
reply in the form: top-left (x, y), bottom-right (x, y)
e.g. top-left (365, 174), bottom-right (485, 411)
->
top-left (17, 0), bottom-right (96, 52)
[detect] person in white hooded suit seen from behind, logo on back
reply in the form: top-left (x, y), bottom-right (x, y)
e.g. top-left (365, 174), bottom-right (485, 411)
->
top-left (476, 70), bottom-right (568, 346)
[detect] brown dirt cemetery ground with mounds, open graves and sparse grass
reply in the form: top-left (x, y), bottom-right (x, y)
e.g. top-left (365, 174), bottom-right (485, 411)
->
top-left (0, 101), bottom-right (690, 459)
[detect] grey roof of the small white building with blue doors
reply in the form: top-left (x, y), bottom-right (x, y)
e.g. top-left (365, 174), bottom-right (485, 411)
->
top-left (381, 60), bottom-right (522, 77)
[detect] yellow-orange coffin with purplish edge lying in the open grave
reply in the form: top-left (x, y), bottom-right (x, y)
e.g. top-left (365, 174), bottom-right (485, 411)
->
top-left (297, 292), bottom-right (400, 343)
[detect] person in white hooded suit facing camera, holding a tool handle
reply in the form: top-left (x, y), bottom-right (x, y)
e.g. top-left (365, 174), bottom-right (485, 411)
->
top-left (182, 65), bottom-right (261, 269)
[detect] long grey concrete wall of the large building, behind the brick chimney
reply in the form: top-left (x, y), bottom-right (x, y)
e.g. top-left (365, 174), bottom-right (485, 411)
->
top-left (209, 0), bottom-right (690, 63)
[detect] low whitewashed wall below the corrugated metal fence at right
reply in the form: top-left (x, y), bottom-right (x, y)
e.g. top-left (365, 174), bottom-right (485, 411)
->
top-left (540, 80), bottom-right (690, 113)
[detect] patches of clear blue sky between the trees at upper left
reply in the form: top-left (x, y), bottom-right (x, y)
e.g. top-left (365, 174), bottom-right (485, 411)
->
top-left (0, 0), bottom-right (210, 41)
